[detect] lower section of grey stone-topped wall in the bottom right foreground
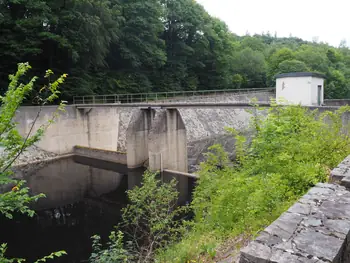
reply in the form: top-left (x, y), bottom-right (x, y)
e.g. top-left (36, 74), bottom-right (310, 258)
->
top-left (240, 184), bottom-right (350, 263)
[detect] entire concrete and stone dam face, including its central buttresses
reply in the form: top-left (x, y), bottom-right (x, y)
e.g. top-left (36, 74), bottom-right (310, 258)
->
top-left (16, 91), bottom-right (274, 172)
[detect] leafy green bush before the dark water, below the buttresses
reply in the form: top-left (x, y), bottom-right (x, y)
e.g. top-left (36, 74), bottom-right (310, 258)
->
top-left (90, 171), bottom-right (187, 263)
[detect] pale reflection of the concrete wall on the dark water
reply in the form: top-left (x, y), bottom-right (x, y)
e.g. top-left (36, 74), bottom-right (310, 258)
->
top-left (25, 159), bottom-right (123, 210)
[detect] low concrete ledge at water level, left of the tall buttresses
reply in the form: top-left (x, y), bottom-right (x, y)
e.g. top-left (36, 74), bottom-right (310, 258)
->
top-left (73, 145), bottom-right (127, 165)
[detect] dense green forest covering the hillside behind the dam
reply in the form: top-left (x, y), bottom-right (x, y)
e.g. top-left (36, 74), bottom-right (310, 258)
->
top-left (0, 0), bottom-right (350, 100)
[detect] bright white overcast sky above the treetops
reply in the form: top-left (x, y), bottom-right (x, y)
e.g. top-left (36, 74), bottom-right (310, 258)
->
top-left (197, 0), bottom-right (350, 46)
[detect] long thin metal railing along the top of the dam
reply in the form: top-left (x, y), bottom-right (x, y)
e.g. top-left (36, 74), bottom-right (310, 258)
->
top-left (73, 88), bottom-right (275, 105)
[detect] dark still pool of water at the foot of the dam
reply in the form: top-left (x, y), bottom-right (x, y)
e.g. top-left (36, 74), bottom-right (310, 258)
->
top-left (0, 157), bottom-right (194, 263)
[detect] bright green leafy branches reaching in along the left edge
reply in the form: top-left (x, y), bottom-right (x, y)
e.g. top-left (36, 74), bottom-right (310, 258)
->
top-left (0, 63), bottom-right (67, 263)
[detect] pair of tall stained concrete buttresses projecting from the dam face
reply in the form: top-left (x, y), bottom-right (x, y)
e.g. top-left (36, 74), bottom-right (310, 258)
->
top-left (127, 109), bottom-right (188, 172)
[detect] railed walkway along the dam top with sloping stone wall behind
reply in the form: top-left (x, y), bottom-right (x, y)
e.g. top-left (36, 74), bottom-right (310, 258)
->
top-left (73, 88), bottom-right (275, 108)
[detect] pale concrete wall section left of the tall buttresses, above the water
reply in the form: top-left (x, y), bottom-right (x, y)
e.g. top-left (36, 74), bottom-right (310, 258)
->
top-left (15, 105), bottom-right (133, 155)
